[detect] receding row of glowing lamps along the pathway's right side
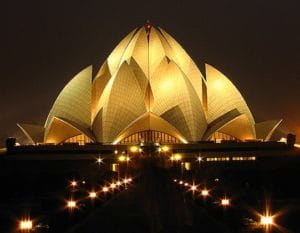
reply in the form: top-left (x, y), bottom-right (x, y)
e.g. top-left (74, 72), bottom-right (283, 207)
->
top-left (173, 179), bottom-right (275, 229)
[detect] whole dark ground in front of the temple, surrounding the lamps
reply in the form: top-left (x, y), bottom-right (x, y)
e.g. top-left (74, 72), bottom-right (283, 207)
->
top-left (0, 153), bottom-right (300, 233)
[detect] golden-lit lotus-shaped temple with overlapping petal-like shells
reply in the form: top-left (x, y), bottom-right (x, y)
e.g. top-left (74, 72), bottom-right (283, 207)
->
top-left (18, 24), bottom-right (281, 144)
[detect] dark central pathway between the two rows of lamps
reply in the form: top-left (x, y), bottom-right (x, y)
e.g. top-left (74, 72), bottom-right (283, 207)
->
top-left (68, 159), bottom-right (228, 233)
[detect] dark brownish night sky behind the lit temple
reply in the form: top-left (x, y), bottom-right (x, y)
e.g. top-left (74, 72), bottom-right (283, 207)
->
top-left (0, 0), bottom-right (300, 144)
